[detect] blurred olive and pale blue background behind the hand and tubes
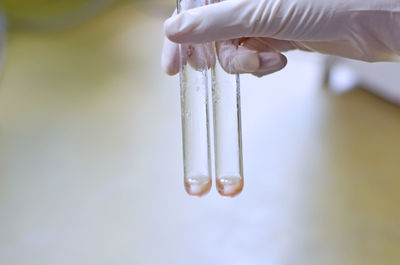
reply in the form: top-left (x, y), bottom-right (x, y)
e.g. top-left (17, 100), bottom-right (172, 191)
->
top-left (0, 0), bottom-right (400, 265)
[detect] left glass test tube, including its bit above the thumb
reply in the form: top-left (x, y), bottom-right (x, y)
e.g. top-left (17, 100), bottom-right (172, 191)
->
top-left (177, 0), bottom-right (212, 196)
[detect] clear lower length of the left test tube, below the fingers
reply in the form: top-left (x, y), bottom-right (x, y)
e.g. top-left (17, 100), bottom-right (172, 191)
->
top-left (180, 64), bottom-right (211, 196)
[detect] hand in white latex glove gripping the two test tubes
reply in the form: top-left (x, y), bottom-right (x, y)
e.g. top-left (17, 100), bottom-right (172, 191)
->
top-left (162, 0), bottom-right (400, 76)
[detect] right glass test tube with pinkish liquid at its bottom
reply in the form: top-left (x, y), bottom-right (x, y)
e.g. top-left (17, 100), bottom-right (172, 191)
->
top-left (212, 60), bottom-right (243, 197)
